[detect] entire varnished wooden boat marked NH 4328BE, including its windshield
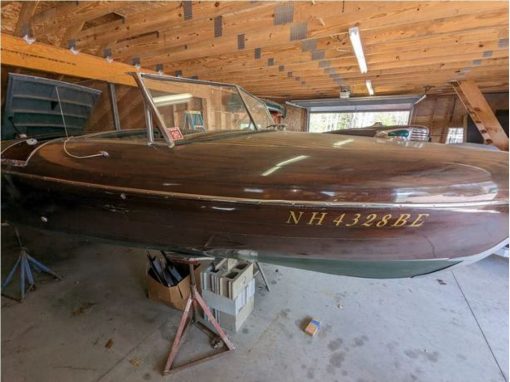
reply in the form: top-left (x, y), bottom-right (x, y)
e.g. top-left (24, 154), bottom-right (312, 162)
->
top-left (2, 75), bottom-right (508, 278)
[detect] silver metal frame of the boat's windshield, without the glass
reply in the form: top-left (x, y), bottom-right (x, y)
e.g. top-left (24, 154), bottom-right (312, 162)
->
top-left (130, 72), bottom-right (272, 148)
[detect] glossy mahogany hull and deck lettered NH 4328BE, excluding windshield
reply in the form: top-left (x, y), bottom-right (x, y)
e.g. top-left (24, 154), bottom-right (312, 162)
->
top-left (2, 133), bottom-right (508, 278)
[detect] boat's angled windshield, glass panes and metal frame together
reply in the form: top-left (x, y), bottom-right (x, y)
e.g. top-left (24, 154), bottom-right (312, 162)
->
top-left (137, 74), bottom-right (273, 141)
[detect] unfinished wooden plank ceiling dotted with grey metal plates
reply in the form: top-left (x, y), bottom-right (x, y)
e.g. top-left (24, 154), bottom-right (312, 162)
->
top-left (1, 1), bottom-right (508, 99)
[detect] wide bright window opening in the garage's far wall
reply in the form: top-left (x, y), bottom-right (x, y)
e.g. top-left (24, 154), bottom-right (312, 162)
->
top-left (309, 110), bottom-right (410, 133)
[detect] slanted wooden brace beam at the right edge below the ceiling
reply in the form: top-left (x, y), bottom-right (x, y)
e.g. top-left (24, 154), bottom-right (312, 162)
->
top-left (452, 81), bottom-right (508, 151)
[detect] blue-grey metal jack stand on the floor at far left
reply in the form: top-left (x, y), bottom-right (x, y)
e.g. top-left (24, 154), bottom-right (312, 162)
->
top-left (2, 227), bottom-right (62, 302)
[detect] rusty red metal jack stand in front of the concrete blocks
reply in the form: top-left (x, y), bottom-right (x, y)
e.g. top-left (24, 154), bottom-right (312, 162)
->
top-left (163, 256), bottom-right (235, 374)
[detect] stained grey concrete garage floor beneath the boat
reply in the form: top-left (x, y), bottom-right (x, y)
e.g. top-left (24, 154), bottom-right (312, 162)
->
top-left (2, 227), bottom-right (508, 382)
